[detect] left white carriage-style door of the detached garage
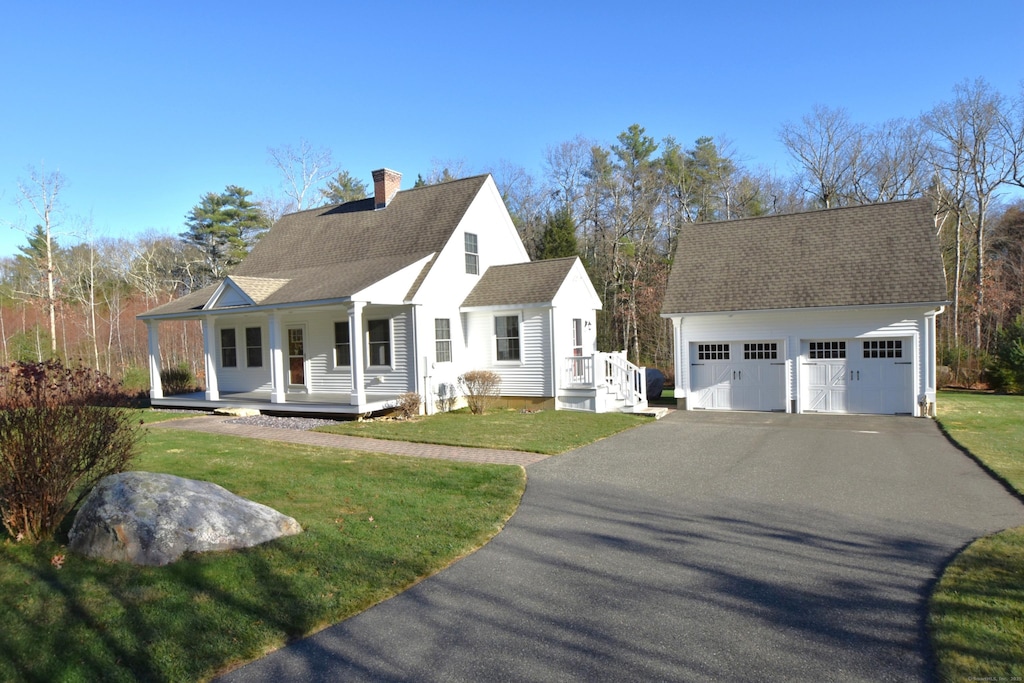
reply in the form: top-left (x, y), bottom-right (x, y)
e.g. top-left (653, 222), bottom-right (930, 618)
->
top-left (690, 341), bottom-right (785, 411)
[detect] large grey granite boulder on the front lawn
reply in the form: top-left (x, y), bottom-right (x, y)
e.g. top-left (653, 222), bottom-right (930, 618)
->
top-left (68, 472), bottom-right (302, 566)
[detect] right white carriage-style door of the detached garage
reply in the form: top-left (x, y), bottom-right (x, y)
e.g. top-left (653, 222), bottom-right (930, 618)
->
top-left (801, 339), bottom-right (913, 415)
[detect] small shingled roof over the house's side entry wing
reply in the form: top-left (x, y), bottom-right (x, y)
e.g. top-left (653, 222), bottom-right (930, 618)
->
top-left (462, 256), bottom-right (577, 308)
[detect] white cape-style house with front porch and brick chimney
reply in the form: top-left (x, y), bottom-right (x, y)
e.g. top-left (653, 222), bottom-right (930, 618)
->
top-left (139, 169), bottom-right (646, 414)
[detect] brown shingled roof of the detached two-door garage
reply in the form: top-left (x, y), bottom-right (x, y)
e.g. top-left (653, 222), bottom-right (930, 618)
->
top-left (662, 200), bottom-right (946, 315)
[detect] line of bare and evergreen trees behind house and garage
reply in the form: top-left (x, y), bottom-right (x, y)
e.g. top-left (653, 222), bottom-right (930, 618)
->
top-left (0, 79), bottom-right (1024, 393)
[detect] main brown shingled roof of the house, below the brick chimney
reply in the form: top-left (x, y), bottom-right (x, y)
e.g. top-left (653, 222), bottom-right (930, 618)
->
top-left (144, 175), bottom-right (487, 317)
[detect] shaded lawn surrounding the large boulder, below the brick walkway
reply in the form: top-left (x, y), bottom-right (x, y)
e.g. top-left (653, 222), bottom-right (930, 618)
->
top-left (0, 428), bottom-right (525, 681)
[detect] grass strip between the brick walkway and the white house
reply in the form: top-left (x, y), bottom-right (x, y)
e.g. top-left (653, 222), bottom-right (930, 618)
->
top-left (316, 410), bottom-right (651, 455)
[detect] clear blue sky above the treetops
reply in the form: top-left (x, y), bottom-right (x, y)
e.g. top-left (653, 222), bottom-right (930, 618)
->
top-left (0, 0), bottom-right (1024, 257)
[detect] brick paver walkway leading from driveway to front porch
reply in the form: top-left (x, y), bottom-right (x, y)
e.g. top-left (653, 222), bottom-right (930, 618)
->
top-left (147, 415), bottom-right (548, 467)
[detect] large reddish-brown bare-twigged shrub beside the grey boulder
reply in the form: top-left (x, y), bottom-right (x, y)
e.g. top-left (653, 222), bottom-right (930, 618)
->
top-left (0, 360), bottom-right (140, 542)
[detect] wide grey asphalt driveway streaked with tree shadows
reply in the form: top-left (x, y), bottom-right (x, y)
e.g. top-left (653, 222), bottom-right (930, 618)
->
top-left (223, 412), bottom-right (1024, 682)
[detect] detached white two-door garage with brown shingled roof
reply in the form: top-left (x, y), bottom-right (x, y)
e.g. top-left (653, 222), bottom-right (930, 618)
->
top-left (662, 200), bottom-right (947, 416)
